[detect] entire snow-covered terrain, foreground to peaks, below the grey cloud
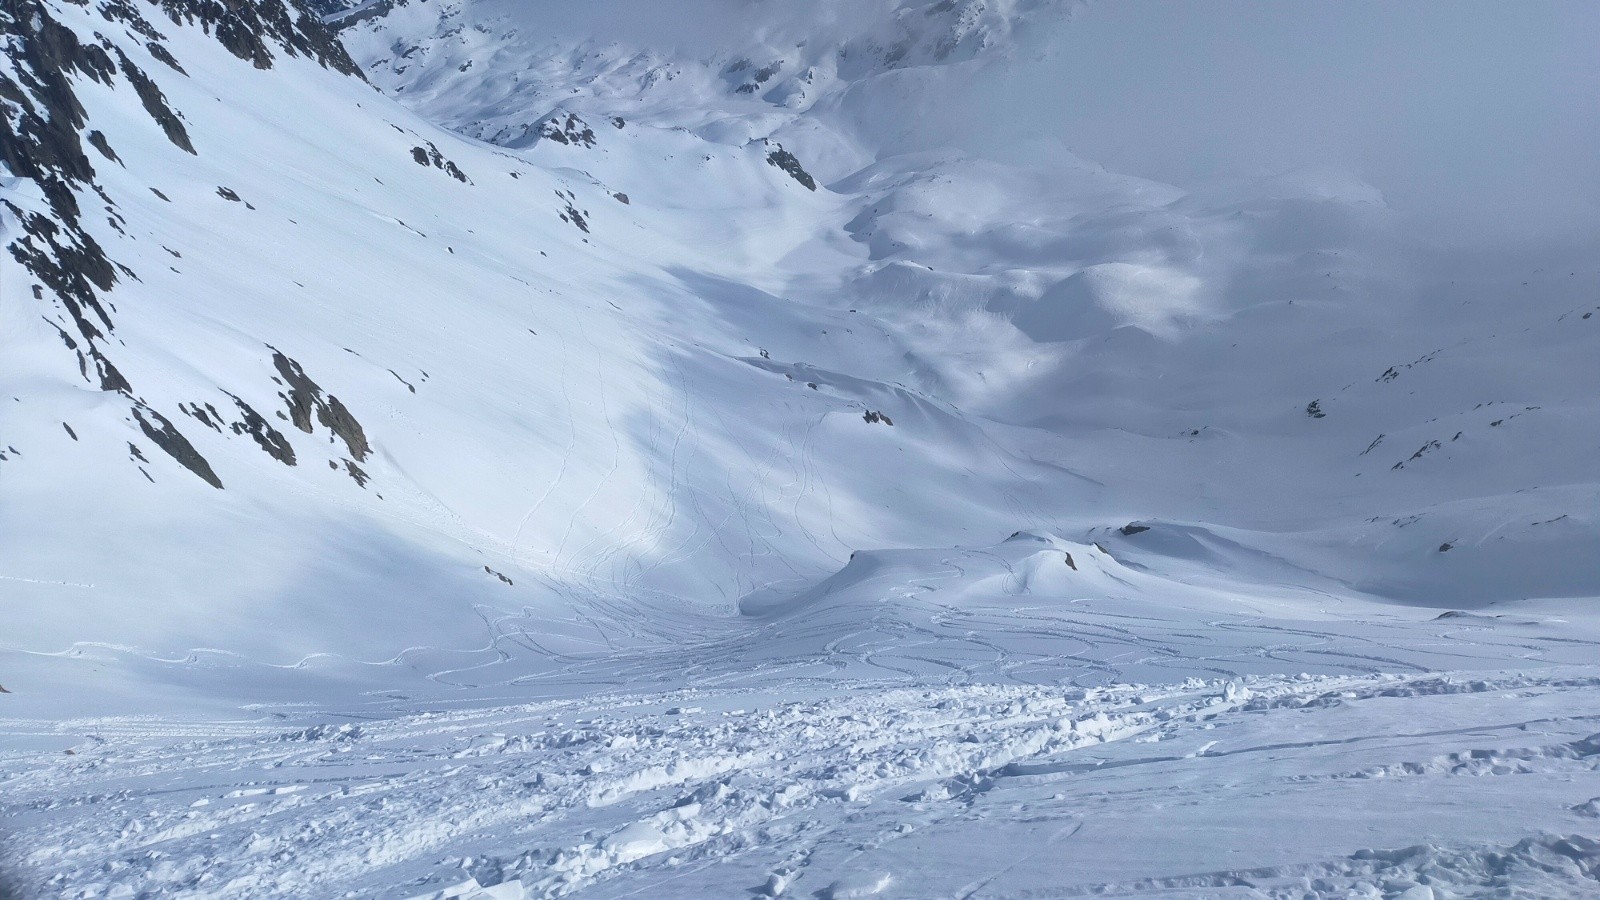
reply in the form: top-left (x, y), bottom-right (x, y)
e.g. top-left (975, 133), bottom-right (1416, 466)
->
top-left (0, 0), bottom-right (1600, 897)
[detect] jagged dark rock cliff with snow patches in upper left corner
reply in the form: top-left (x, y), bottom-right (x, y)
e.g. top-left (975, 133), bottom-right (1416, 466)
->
top-left (0, 0), bottom-right (360, 487)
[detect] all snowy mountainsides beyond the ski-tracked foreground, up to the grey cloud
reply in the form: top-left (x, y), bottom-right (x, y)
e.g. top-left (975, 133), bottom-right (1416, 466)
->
top-left (0, 0), bottom-right (1600, 698)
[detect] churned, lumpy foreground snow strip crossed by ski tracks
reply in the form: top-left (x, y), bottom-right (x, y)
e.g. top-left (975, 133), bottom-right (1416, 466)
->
top-left (0, 669), bottom-right (1600, 898)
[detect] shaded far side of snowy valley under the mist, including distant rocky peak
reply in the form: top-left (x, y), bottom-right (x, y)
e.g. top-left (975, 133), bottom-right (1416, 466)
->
top-left (344, 0), bottom-right (1600, 604)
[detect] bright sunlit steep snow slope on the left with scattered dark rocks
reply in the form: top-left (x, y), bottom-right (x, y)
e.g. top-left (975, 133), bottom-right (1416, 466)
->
top-left (6, 0), bottom-right (1077, 672)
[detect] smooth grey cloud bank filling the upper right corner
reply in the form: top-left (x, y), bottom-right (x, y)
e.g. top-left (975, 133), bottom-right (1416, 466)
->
top-left (940, 0), bottom-right (1600, 245)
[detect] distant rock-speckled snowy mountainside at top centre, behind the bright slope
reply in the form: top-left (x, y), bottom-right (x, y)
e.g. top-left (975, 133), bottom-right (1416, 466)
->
top-left (334, 0), bottom-right (1080, 154)
